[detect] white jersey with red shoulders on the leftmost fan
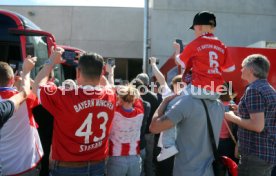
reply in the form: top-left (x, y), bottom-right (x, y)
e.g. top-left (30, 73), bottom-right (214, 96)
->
top-left (0, 90), bottom-right (43, 175)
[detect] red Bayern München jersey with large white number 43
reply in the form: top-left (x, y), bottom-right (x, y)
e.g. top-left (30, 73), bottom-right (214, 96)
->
top-left (38, 85), bottom-right (116, 161)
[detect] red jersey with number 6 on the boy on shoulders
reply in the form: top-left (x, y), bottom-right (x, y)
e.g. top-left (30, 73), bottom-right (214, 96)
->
top-left (177, 33), bottom-right (235, 92)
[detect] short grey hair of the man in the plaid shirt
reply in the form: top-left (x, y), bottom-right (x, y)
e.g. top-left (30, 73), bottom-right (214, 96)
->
top-left (242, 54), bottom-right (270, 79)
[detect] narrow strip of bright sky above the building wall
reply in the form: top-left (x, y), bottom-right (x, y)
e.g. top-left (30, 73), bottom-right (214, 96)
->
top-left (0, 0), bottom-right (144, 8)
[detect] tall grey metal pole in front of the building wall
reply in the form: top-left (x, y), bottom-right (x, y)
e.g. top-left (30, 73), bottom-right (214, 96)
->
top-left (143, 0), bottom-right (149, 73)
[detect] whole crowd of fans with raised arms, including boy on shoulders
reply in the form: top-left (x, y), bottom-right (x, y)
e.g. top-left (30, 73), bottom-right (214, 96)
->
top-left (0, 11), bottom-right (276, 176)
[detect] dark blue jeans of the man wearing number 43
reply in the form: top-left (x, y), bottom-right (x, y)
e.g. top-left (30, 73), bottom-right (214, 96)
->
top-left (50, 161), bottom-right (105, 176)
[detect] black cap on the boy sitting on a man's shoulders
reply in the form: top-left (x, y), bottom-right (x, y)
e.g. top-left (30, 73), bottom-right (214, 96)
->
top-left (190, 11), bottom-right (217, 30)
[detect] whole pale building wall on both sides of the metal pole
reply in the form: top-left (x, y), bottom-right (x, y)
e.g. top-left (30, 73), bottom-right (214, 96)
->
top-left (1, 0), bottom-right (276, 65)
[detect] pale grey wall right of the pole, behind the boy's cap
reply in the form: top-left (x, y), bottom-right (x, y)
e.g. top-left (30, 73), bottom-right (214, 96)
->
top-left (150, 0), bottom-right (276, 65)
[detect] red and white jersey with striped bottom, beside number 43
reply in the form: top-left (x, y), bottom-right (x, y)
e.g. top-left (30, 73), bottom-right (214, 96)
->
top-left (110, 99), bottom-right (144, 156)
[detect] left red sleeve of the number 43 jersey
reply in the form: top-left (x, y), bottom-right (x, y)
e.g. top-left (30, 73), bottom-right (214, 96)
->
top-left (38, 84), bottom-right (62, 114)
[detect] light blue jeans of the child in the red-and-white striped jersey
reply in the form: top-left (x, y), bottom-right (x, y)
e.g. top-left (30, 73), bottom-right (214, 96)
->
top-left (107, 155), bottom-right (141, 176)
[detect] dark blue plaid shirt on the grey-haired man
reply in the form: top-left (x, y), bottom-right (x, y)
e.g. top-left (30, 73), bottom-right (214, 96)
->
top-left (238, 79), bottom-right (276, 164)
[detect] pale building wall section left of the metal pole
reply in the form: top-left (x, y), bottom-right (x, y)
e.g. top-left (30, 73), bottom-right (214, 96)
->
top-left (1, 6), bottom-right (143, 58)
